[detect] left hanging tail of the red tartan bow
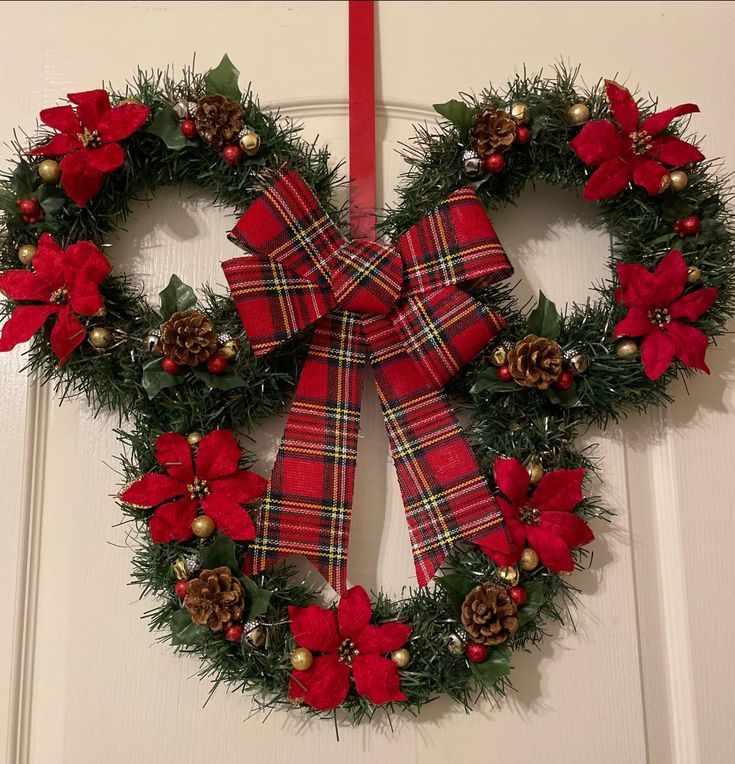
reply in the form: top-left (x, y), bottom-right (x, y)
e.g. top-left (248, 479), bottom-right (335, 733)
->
top-left (245, 311), bottom-right (365, 593)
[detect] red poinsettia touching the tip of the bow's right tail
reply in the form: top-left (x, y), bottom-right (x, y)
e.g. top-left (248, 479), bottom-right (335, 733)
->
top-left (479, 459), bottom-right (594, 572)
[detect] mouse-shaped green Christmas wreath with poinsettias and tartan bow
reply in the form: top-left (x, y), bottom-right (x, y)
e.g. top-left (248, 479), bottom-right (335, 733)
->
top-left (0, 57), bottom-right (735, 722)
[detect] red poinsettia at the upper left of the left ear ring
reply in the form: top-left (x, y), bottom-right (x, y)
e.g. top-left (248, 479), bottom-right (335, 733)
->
top-left (31, 90), bottom-right (150, 207)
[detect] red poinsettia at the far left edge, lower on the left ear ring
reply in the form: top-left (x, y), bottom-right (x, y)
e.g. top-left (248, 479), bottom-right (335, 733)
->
top-left (0, 233), bottom-right (110, 366)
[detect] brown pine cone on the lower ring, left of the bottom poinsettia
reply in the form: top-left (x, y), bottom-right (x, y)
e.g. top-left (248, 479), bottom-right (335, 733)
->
top-left (184, 567), bottom-right (245, 631)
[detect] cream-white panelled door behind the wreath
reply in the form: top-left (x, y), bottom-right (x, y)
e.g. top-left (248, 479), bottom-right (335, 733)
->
top-left (0, 1), bottom-right (735, 764)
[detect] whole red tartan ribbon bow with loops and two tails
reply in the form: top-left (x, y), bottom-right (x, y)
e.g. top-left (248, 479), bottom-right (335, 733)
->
top-left (222, 169), bottom-right (512, 593)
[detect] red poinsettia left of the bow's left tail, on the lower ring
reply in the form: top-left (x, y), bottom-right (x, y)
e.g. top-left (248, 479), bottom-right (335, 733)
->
top-left (120, 430), bottom-right (267, 544)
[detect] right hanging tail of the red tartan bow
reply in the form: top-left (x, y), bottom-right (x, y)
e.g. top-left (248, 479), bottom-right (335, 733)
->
top-left (363, 317), bottom-right (509, 586)
